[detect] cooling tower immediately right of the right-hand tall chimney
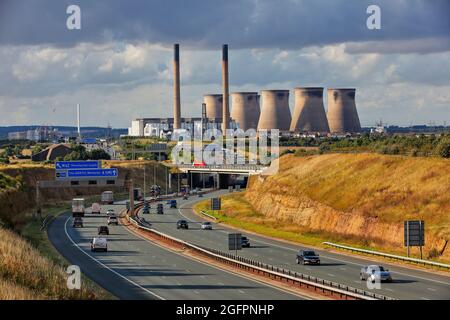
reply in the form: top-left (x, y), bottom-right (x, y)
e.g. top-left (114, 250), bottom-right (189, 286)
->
top-left (231, 92), bottom-right (260, 131)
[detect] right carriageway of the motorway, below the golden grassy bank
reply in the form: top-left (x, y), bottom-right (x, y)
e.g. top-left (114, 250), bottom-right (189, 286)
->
top-left (142, 190), bottom-right (450, 300)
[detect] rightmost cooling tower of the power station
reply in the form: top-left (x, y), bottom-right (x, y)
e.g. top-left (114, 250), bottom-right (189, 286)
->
top-left (327, 89), bottom-right (361, 133)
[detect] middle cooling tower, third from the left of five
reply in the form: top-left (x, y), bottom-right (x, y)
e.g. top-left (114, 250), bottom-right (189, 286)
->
top-left (258, 90), bottom-right (291, 131)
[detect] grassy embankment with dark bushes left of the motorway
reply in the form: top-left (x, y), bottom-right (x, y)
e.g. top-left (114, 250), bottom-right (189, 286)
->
top-left (0, 166), bottom-right (112, 300)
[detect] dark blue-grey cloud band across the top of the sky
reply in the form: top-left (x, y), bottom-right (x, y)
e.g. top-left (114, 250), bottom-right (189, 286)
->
top-left (0, 0), bottom-right (450, 52)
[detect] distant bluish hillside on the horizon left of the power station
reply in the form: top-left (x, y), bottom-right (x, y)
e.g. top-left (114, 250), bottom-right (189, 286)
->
top-left (0, 125), bottom-right (128, 139)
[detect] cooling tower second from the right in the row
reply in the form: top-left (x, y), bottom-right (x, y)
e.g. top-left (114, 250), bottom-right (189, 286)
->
top-left (290, 87), bottom-right (330, 132)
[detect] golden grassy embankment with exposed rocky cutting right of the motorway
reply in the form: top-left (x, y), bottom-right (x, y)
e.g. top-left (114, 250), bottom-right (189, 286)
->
top-left (195, 154), bottom-right (450, 262)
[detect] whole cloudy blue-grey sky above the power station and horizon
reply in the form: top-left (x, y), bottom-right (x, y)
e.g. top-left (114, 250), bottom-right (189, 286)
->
top-left (0, 0), bottom-right (450, 127)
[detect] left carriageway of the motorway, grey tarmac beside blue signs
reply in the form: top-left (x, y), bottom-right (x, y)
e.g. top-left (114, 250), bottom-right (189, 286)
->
top-left (48, 204), bottom-right (305, 300)
